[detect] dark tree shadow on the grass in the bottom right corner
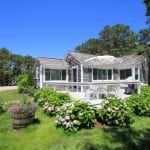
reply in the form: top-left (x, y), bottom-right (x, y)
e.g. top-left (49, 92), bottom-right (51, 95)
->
top-left (82, 127), bottom-right (150, 150)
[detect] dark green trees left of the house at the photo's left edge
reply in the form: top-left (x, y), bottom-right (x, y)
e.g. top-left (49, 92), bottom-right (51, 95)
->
top-left (0, 48), bottom-right (35, 86)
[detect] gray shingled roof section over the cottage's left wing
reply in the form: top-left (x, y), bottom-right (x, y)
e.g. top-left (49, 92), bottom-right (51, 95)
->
top-left (37, 57), bottom-right (68, 69)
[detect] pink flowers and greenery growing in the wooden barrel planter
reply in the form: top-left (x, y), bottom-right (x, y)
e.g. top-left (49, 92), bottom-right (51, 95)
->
top-left (9, 96), bottom-right (37, 113)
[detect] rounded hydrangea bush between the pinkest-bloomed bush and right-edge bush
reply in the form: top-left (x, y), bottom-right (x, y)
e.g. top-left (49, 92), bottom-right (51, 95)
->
top-left (97, 97), bottom-right (133, 126)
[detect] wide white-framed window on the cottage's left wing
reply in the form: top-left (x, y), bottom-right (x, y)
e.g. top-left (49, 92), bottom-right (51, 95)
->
top-left (45, 69), bottom-right (66, 81)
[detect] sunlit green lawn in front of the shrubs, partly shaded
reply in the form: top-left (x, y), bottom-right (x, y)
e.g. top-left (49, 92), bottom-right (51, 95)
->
top-left (0, 90), bottom-right (150, 150)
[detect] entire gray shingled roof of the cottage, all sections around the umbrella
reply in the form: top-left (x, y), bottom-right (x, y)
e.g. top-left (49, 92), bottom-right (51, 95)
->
top-left (38, 52), bottom-right (143, 68)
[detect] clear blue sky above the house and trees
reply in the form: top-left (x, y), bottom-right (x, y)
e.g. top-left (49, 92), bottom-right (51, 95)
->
top-left (0, 0), bottom-right (147, 58)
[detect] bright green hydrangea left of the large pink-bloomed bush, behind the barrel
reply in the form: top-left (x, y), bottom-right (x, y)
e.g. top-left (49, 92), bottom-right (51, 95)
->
top-left (34, 88), bottom-right (71, 116)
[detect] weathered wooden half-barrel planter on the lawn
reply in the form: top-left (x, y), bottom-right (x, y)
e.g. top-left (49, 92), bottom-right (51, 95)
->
top-left (12, 110), bottom-right (35, 129)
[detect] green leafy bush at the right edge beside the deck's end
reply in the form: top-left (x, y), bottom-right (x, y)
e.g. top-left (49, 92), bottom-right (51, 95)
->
top-left (128, 87), bottom-right (150, 116)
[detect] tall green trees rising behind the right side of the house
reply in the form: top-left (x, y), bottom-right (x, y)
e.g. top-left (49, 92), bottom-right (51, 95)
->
top-left (75, 24), bottom-right (150, 56)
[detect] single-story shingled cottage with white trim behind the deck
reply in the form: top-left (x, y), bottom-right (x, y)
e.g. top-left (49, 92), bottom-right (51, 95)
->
top-left (34, 52), bottom-right (143, 95)
